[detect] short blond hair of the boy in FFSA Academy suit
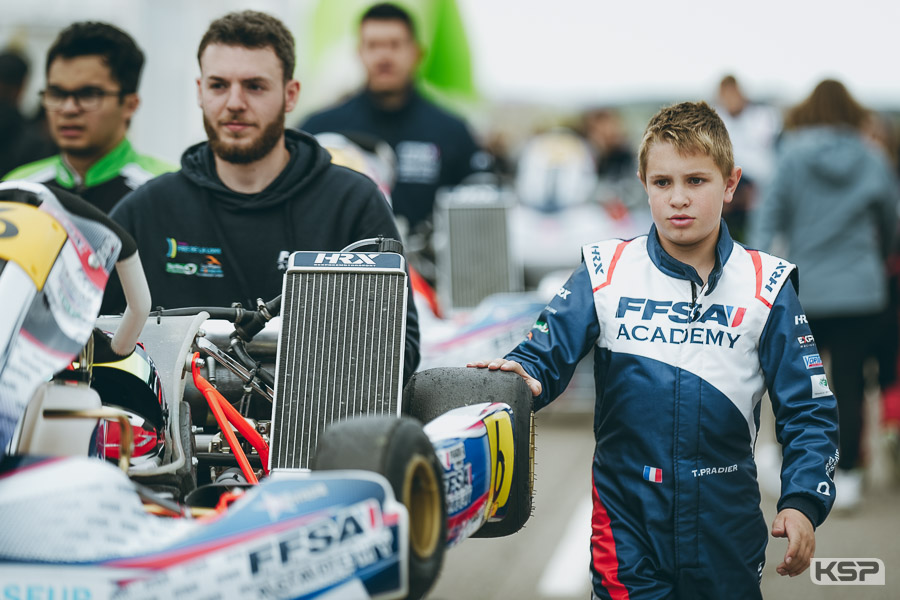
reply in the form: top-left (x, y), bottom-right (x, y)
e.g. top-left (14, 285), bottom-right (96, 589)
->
top-left (638, 101), bottom-right (734, 180)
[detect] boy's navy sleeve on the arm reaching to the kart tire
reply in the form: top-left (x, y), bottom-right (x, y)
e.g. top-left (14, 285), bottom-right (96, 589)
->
top-left (506, 262), bottom-right (600, 410)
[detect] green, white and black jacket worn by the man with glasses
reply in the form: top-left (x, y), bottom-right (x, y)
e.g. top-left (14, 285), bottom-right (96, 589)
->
top-left (4, 139), bottom-right (176, 213)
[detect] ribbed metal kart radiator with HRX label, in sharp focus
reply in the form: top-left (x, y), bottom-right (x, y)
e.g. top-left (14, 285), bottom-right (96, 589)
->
top-left (270, 252), bottom-right (407, 469)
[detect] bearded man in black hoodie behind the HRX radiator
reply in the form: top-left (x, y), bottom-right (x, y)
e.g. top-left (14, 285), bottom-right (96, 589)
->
top-left (104, 11), bottom-right (419, 379)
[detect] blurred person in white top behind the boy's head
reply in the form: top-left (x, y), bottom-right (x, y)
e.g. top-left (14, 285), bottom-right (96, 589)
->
top-left (716, 75), bottom-right (781, 242)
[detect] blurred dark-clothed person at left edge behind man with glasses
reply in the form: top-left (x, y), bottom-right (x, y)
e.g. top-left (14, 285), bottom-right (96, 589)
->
top-left (0, 50), bottom-right (56, 175)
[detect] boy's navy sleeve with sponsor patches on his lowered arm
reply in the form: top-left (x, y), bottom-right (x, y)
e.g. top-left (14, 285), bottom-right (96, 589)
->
top-left (760, 276), bottom-right (839, 526)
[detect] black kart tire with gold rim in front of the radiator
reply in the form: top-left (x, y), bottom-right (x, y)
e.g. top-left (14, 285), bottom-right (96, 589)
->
top-left (311, 417), bottom-right (447, 600)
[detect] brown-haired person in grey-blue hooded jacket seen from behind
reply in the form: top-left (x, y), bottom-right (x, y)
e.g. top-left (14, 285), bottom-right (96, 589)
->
top-left (750, 79), bottom-right (900, 510)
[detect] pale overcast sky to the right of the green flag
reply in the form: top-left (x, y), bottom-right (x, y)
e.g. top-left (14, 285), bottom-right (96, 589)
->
top-left (457, 0), bottom-right (900, 106)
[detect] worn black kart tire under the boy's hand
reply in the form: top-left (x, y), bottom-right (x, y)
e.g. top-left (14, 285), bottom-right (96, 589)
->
top-left (403, 367), bottom-right (534, 537)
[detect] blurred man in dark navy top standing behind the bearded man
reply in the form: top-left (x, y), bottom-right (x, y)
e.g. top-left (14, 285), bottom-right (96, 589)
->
top-left (300, 3), bottom-right (490, 280)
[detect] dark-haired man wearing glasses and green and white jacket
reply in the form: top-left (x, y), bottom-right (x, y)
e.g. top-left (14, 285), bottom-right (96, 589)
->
top-left (4, 22), bottom-right (176, 212)
